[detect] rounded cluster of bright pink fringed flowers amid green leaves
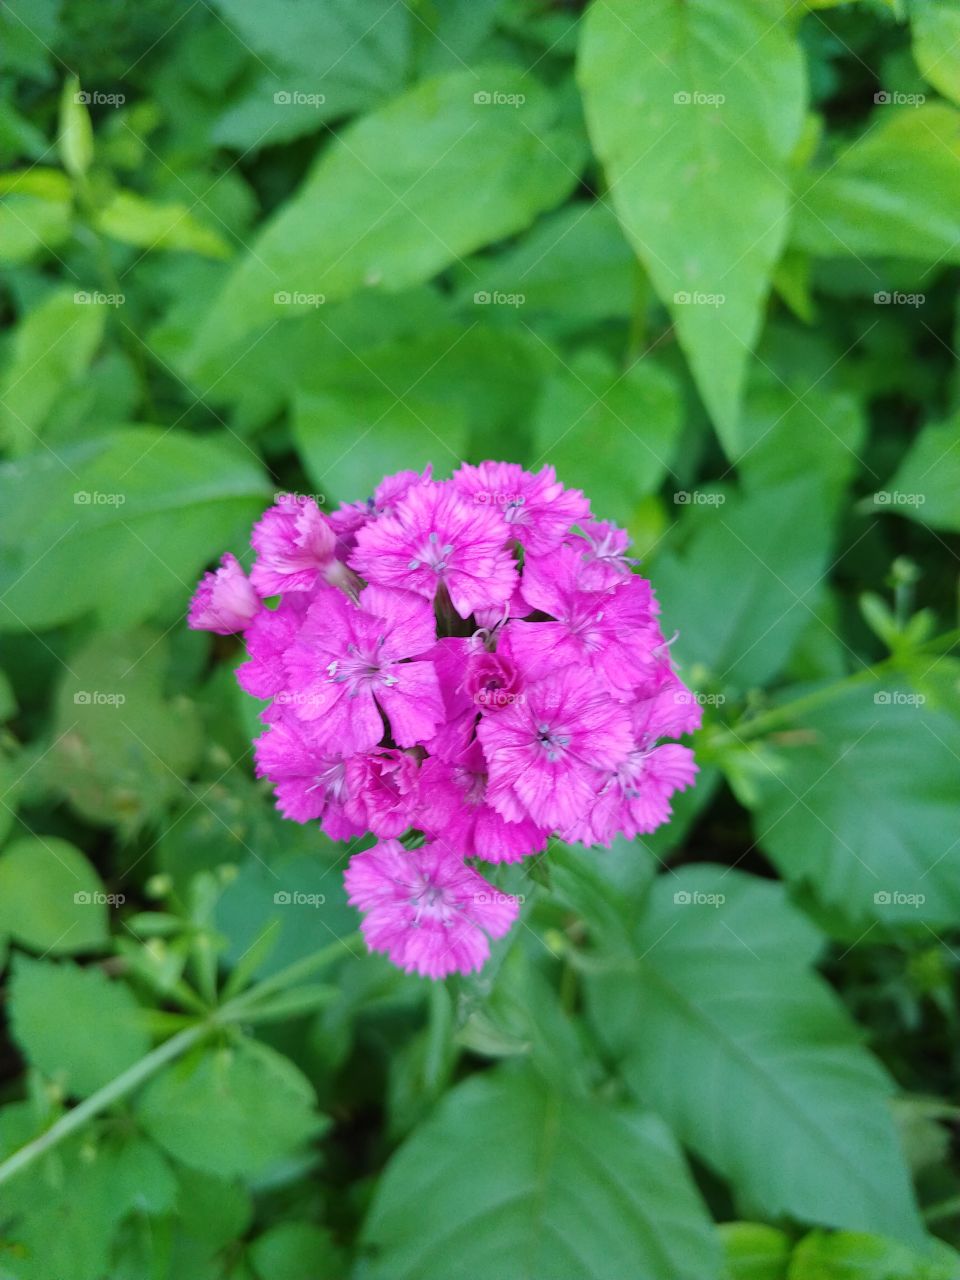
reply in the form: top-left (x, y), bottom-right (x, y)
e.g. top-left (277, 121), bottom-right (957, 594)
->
top-left (189, 462), bottom-right (700, 978)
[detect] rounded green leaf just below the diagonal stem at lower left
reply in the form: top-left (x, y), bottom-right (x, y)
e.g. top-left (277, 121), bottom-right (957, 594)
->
top-left (137, 1041), bottom-right (323, 1175)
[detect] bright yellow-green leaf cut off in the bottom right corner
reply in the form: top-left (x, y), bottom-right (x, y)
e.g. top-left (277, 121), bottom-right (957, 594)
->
top-left (787, 1231), bottom-right (960, 1280)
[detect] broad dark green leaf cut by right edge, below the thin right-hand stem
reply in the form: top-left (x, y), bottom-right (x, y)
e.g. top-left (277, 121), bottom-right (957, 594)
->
top-left (754, 663), bottom-right (960, 928)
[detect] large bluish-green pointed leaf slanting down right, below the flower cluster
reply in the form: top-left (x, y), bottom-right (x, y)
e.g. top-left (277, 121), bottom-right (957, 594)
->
top-left (588, 864), bottom-right (919, 1239)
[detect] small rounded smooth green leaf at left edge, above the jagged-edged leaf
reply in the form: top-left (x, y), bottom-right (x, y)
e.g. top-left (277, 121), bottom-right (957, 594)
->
top-left (0, 836), bottom-right (108, 955)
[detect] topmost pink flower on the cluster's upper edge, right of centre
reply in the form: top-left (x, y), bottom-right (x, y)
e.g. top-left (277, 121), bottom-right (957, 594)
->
top-left (453, 462), bottom-right (590, 556)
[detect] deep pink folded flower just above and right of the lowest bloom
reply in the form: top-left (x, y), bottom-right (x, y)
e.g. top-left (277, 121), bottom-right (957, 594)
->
top-left (417, 742), bottom-right (549, 863)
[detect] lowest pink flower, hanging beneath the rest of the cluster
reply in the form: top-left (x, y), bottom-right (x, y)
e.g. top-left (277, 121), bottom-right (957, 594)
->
top-left (344, 840), bottom-right (520, 978)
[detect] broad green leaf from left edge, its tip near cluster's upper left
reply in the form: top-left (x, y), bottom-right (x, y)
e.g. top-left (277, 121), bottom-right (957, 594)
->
top-left (0, 426), bottom-right (271, 631)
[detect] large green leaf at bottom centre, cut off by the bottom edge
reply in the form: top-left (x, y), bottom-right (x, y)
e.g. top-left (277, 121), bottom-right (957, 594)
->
top-left (362, 1069), bottom-right (719, 1280)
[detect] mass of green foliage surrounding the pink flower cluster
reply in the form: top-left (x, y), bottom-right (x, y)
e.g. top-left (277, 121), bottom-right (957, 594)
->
top-left (0, 0), bottom-right (960, 1280)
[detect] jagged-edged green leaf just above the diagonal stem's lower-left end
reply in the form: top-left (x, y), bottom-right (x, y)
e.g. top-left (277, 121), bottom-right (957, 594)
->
top-left (10, 956), bottom-right (150, 1098)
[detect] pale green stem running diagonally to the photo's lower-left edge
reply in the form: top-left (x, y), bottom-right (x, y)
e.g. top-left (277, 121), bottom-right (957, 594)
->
top-left (0, 933), bottom-right (361, 1185)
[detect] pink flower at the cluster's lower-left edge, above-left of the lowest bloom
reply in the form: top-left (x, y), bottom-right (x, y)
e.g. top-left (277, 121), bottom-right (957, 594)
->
top-left (253, 719), bottom-right (366, 840)
